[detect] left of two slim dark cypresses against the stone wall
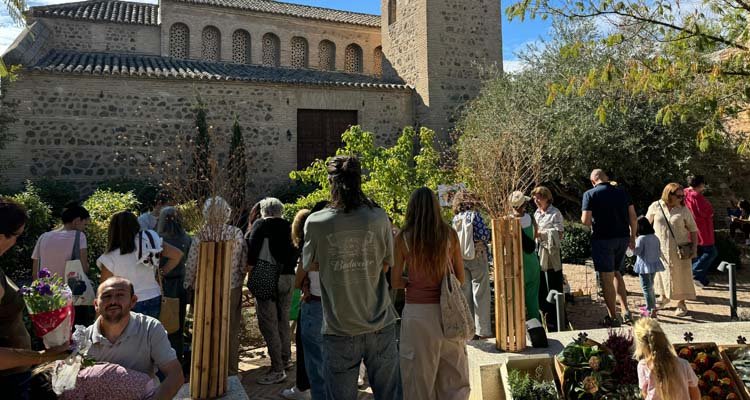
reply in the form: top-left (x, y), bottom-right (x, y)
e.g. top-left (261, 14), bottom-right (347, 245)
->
top-left (190, 94), bottom-right (211, 200)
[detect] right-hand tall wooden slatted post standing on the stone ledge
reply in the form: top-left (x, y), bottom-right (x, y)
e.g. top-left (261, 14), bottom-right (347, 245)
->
top-left (492, 217), bottom-right (526, 352)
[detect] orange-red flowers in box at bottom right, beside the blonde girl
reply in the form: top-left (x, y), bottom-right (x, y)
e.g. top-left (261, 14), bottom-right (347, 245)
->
top-left (674, 343), bottom-right (742, 400)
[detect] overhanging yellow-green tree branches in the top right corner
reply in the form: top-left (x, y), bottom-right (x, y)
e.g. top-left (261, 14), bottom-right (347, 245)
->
top-left (506, 0), bottom-right (750, 150)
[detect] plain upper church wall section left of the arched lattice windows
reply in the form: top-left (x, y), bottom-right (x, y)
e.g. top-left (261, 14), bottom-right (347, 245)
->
top-left (37, 18), bottom-right (161, 55)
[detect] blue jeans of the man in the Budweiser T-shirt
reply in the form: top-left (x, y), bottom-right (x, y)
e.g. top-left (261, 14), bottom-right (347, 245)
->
top-left (323, 324), bottom-right (404, 400)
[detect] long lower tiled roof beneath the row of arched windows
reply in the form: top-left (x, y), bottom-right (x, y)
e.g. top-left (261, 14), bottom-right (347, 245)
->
top-left (29, 49), bottom-right (409, 90)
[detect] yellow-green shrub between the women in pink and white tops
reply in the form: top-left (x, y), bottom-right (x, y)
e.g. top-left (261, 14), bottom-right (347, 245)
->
top-left (83, 189), bottom-right (139, 282)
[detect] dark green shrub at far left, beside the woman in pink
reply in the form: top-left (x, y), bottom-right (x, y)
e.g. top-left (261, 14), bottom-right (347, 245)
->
top-left (0, 182), bottom-right (53, 284)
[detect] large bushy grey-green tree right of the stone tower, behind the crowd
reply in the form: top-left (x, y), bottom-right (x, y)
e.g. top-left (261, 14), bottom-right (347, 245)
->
top-left (459, 19), bottom-right (742, 213)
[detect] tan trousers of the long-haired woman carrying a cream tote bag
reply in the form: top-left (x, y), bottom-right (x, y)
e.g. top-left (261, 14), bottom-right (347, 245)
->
top-left (400, 303), bottom-right (471, 400)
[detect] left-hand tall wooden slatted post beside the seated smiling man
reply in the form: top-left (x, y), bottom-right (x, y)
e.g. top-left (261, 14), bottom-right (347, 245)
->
top-left (190, 241), bottom-right (232, 399)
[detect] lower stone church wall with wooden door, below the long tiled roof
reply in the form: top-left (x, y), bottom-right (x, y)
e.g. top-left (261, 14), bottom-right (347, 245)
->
top-left (0, 73), bottom-right (413, 196)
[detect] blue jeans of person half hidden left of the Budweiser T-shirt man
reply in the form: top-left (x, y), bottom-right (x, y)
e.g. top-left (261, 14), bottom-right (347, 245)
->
top-left (300, 300), bottom-right (327, 400)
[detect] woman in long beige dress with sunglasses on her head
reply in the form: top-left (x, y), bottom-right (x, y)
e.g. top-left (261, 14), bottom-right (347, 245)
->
top-left (646, 183), bottom-right (698, 317)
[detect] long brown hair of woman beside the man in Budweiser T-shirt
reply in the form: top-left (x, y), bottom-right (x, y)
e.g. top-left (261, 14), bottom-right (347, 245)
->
top-left (398, 187), bottom-right (453, 280)
